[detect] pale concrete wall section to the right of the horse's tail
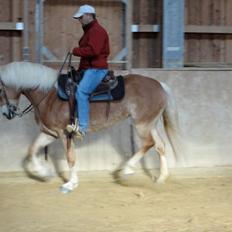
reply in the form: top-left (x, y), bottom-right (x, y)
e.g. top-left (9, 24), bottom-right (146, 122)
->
top-left (135, 70), bottom-right (232, 167)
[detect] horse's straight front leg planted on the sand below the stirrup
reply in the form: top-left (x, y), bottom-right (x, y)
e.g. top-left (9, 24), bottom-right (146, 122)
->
top-left (60, 138), bottom-right (79, 193)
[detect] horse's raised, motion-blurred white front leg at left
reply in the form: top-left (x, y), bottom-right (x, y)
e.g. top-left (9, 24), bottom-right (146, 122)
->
top-left (24, 132), bottom-right (56, 180)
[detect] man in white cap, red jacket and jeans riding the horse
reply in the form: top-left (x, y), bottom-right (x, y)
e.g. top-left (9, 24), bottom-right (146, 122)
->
top-left (67, 5), bottom-right (110, 138)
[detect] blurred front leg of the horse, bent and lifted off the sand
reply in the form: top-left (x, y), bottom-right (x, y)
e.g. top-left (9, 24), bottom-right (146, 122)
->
top-left (25, 132), bottom-right (56, 178)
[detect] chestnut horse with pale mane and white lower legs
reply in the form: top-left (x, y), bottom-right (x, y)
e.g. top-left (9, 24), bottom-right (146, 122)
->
top-left (0, 62), bottom-right (181, 192)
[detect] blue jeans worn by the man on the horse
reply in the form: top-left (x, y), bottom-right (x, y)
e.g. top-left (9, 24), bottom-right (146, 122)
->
top-left (76, 69), bottom-right (108, 132)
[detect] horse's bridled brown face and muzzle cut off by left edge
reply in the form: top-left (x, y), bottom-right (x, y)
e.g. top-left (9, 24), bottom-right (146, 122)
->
top-left (0, 80), bottom-right (20, 119)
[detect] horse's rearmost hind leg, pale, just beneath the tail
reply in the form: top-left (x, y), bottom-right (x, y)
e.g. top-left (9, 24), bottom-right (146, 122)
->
top-left (151, 129), bottom-right (169, 183)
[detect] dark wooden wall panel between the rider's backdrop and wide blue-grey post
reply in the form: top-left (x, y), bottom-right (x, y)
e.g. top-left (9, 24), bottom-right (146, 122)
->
top-left (133, 0), bottom-right (162, 68)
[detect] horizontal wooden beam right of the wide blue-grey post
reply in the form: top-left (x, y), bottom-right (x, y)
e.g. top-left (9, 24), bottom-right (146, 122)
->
top-left (185, 25), bottom-right (232, 34)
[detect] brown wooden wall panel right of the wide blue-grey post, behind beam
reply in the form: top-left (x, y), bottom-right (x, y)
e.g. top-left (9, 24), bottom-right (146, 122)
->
top-left (185, 0), bottom-right (232, 65)
